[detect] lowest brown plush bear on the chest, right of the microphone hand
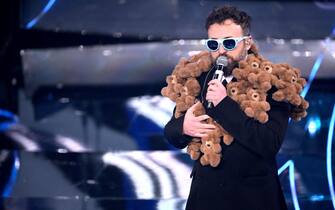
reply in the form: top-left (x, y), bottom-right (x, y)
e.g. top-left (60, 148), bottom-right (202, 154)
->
top-left (241, 88), bottom-right (270, 123)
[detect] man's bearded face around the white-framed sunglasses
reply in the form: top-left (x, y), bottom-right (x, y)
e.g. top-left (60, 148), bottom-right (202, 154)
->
top-left (208, 19), bottom-right (251, 65)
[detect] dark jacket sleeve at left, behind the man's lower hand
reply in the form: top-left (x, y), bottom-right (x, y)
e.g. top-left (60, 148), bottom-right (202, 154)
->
top-left (164, 108), bottom-right (192, 149)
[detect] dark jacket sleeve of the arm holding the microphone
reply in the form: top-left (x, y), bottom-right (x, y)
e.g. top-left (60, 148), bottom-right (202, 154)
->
top-left (206, 88), bottom-right (290, 157)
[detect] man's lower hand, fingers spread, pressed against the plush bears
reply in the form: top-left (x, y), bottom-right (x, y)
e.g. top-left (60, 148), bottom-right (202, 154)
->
top-left (183, 102), bottom-right (215, 138)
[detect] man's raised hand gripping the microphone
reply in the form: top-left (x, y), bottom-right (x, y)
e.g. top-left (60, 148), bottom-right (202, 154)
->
top-left (206, 79), bottom-right (227, 106)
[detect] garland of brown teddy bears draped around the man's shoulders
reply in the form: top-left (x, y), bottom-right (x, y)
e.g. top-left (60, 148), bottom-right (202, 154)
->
top-left (161, 49), bottom-right (309, 167)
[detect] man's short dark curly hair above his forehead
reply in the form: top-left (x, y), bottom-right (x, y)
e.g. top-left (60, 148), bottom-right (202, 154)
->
top-left (206, 5), bottom-right (251, 35)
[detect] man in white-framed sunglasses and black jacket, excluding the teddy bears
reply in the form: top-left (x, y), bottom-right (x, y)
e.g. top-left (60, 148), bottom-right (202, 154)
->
top-left (164, 6), bottom-right (290, 210)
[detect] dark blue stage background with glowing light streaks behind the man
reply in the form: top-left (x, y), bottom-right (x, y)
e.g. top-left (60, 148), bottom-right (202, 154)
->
top-left (0, 0), bottom-right (335, 210)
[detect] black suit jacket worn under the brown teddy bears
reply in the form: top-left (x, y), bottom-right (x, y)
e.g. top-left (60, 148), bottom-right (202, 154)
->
top-left (164, 67), bottom-right (290, 210)
